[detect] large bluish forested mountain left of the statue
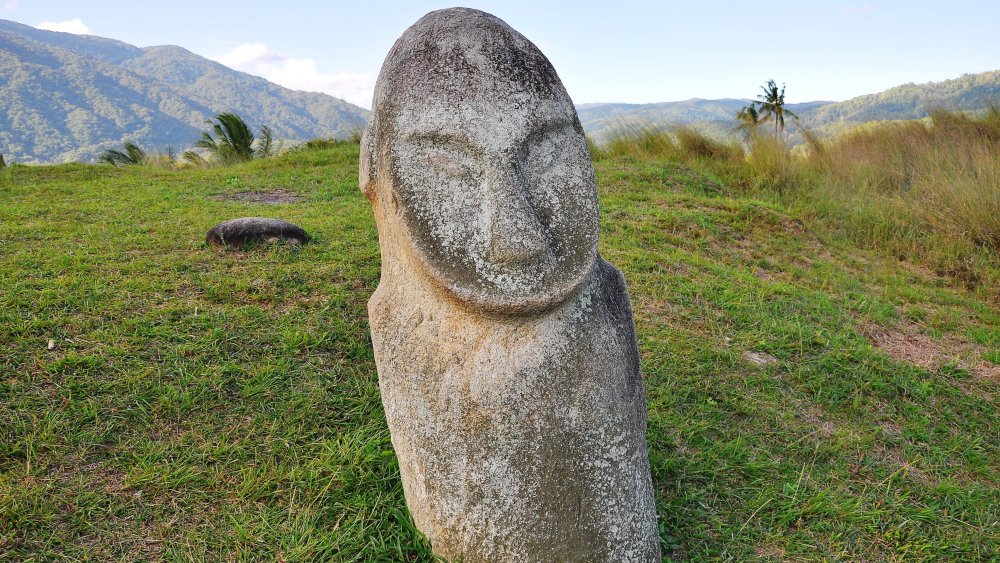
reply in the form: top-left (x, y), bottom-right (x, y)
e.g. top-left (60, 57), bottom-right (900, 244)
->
top-left (0, 20), bottom-right (368, 163)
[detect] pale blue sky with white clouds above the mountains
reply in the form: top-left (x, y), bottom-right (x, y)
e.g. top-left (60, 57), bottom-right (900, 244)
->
top-left (0, 0), bottom-right (1000, 108)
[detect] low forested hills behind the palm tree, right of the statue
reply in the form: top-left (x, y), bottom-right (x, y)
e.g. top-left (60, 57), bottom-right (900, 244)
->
top-left (578, 71), bottom-right (1000, 139)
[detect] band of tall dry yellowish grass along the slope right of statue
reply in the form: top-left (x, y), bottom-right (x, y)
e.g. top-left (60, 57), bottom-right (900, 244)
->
top-left (592, 106), bottom-right (1000, 298)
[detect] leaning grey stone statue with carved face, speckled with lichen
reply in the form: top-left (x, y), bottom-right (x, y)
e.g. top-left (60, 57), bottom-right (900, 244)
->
top-left (360, 8), bottom-right (660, 562)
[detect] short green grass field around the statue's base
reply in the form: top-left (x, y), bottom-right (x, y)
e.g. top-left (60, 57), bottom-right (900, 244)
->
top-left (0, 144), bottom-right (1000, 561)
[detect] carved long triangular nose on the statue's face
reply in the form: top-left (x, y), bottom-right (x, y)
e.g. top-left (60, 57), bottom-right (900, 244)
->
top-left (487, 161), bottom-right (547, 264)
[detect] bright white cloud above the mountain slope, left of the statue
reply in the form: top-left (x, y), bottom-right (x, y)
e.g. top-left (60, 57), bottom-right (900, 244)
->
top-left (209, 43), bottom-right (375, 107)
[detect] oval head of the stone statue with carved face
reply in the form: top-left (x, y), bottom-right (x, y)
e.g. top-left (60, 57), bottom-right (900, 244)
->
top-left (360, 8), bottom-right (598, 314)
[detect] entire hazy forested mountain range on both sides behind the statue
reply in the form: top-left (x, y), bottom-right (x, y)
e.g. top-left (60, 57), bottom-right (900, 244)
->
top-left (0, 20), bottom-right (1000, 163)
